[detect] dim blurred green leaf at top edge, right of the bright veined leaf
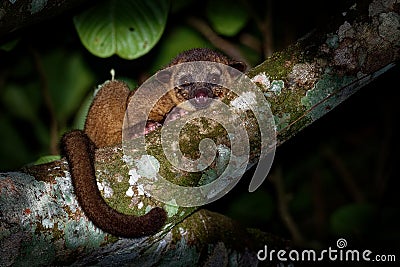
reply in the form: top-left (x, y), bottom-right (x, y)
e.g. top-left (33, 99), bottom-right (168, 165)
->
top-left (206, 0), bottom-right (249, 36)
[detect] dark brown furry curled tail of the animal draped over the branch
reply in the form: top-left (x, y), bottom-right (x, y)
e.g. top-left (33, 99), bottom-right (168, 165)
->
top-left (61, 130), bottom-right (167, 238)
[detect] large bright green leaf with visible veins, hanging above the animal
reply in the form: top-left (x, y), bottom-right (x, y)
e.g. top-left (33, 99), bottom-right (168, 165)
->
top-left (74, 0), bottom-right (169, 59)
